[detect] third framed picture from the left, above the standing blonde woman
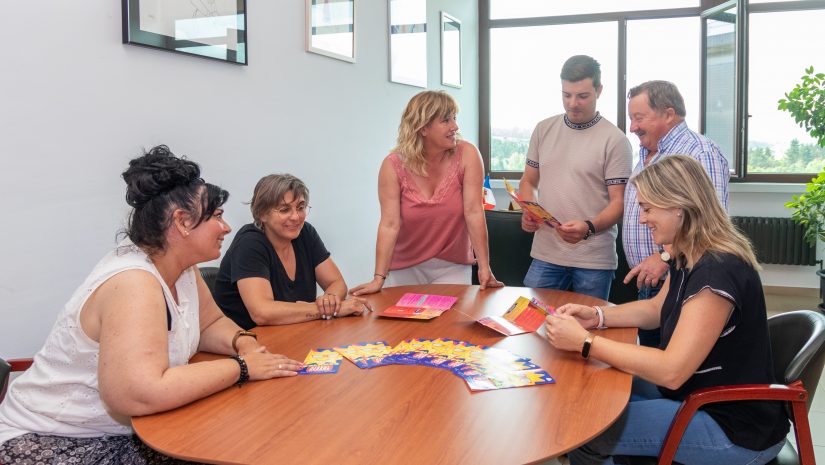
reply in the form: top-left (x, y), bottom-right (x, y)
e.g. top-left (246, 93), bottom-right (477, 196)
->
top-left (388, 0), bottom-right (427, 87)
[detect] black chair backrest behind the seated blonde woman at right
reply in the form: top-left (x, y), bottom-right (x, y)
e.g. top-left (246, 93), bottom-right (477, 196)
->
top-left (768, 310), bottom-right (825, 409)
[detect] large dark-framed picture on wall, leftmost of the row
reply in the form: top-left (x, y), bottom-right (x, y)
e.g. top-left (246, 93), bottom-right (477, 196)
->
top-left (121, 0), bottom-right (248, 65)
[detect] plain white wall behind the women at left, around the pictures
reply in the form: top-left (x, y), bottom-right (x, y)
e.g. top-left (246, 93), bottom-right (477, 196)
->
top-left (0, 0), bottom-right (478, 358)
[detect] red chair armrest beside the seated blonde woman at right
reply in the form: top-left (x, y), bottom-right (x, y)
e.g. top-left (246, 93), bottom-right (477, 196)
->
top-left (659, 381), bottom-right (813, 465)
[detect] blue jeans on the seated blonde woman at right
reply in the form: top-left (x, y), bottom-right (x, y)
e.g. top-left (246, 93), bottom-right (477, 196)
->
top-left (568, 378), bottom-right (785, 465)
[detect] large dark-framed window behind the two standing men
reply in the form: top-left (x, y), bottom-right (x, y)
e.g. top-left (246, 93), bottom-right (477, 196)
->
top-left (479, 0), bottom-right (825, 182)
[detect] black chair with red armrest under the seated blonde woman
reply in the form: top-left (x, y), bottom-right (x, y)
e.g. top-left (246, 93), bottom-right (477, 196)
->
top-left (628, 310), bottom-right (825, 465)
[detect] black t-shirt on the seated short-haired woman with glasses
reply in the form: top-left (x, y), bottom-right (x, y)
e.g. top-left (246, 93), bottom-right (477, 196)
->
top-left (215, 223), bottom-right (330, 329)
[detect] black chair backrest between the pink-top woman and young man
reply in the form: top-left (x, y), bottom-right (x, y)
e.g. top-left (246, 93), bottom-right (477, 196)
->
top-left (484, 210), bottom-right (533, 286)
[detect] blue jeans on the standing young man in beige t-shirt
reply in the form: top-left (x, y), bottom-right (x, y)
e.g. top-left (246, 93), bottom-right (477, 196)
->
top-left (524, 258), bottom-right (616, 300)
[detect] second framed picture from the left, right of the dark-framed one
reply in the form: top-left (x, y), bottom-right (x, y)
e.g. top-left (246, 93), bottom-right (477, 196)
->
top-left (304, 0), bottom-right (355, 63)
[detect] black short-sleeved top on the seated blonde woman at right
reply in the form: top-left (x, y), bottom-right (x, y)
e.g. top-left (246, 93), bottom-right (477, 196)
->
top-left (659, 253), bottom-right (789, 450)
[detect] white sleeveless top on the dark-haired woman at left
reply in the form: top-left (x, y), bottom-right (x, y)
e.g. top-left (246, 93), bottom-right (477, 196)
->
top-left (0, 239), bottom-right (200, 444)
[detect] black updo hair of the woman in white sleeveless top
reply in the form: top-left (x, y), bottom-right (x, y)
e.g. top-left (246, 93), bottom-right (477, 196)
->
top-left (122, 145), bottom-right (229, 254)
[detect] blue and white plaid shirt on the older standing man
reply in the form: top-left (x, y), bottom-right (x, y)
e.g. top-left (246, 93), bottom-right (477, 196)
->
top-left (622, 121), bottom-right (730, 268)
